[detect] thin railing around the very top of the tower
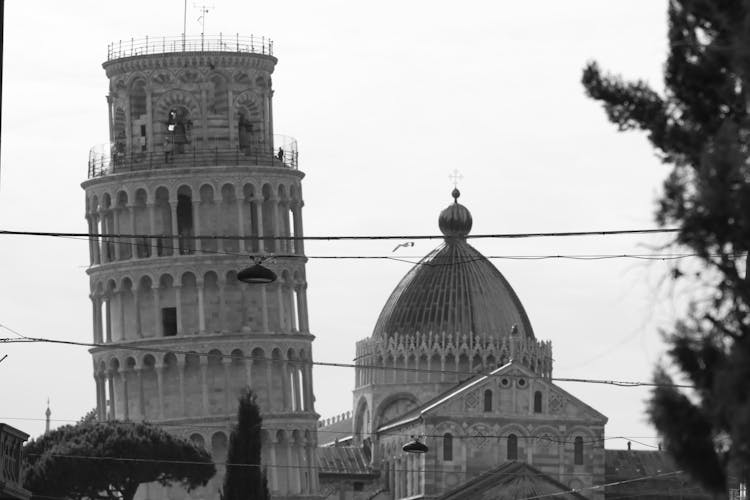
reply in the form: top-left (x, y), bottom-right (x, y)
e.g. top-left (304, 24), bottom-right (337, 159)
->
top-left (107, 33), bottom-right (273, 61)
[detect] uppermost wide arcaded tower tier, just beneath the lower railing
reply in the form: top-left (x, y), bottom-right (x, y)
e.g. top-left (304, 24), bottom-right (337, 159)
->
top-left (86, 183), bottom-right (304, 265)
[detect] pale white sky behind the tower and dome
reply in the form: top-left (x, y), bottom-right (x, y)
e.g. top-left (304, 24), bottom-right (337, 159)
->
top-left (0, 0), bottom-right (679, 448)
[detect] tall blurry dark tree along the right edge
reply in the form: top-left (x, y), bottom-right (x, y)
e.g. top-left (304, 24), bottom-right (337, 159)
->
top-left (582, 0), bottom-right (750, 494)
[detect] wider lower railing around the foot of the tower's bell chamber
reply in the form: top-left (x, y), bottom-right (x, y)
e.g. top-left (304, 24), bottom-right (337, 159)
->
top-left (88, 135), bottom-right (299, 179)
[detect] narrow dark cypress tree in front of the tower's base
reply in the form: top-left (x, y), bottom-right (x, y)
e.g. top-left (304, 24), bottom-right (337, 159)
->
top-left (222, 389), bottom-right (270, 500)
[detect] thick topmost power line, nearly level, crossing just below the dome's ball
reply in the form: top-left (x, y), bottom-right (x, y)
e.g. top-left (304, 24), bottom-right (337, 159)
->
top-left (0, 228), bottom-right (680, 241)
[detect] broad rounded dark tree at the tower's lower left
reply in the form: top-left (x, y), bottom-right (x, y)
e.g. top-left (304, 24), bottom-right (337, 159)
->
top-left (24, 420), bottom-right (216, 500)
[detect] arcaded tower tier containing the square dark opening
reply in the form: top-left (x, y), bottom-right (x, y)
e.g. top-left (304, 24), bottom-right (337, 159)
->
top-left (91, 269), bottom-right (309, 343)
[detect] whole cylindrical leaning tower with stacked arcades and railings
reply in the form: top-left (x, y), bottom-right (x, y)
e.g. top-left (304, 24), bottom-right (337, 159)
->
top-left (82, 36), bottom-right (318, 499)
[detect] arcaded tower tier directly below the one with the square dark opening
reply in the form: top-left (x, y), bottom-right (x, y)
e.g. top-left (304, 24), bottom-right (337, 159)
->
top-left (94, 347), bottom-right (314, 421)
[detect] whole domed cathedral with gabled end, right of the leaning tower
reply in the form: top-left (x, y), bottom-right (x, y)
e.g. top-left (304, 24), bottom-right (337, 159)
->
top-left (319, 190), bottom-right (607, 500)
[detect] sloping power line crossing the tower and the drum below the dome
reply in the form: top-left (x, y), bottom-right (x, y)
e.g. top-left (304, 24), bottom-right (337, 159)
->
top-left (0, 330), bottom-right (694, 389)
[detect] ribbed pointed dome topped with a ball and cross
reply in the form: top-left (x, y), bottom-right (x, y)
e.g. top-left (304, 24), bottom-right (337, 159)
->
top-left (373, 190), bottom-right (534, 338)
